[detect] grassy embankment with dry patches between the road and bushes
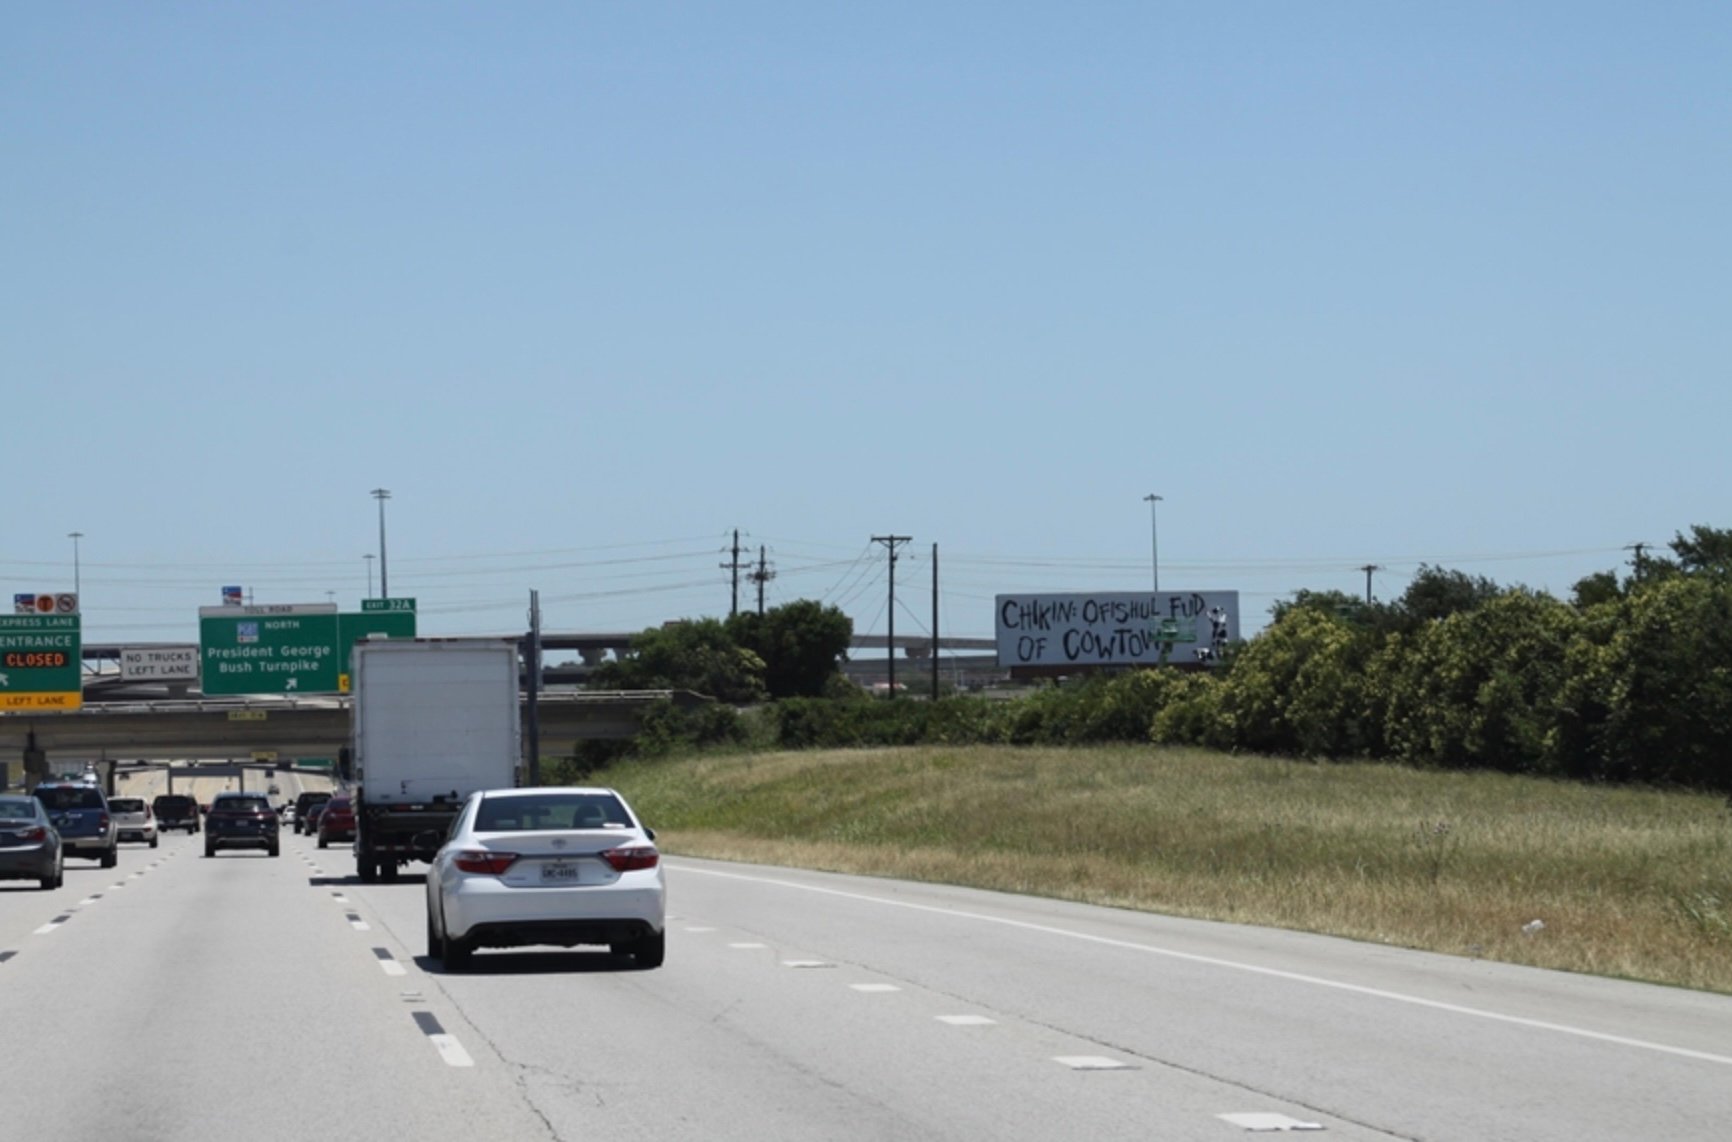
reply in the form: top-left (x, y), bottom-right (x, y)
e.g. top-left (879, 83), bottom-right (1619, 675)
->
top-left (599, 747), bottom-right (1732, 993)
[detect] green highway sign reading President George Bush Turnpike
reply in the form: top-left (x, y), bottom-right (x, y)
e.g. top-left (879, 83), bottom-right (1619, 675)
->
top-left (199, 603), bottom-right (346, 695)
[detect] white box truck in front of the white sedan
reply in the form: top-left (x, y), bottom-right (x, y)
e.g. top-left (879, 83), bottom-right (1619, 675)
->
top-left (350, 638), bottom-right (523, 884)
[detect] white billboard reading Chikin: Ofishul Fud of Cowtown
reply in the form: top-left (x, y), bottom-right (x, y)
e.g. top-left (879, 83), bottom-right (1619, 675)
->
top-left (994, 591), bottom-right (1240, 669)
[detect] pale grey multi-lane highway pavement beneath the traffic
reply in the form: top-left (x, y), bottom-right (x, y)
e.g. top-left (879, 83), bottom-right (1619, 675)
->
top-left (0, 817), bottom-right (1732, 1142)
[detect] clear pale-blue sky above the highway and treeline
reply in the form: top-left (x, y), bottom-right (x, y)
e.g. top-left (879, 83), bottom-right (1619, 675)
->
top-left (0, 0), bottom-right (1732, 643)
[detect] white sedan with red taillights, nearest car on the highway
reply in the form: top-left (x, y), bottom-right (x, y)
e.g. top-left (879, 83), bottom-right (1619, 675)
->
top-left (426, 787), bottom-right (667, 970)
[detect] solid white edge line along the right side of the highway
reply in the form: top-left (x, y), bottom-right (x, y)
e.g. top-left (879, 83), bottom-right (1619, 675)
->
top-left (675, 865), bottom-right (1732, 1066)
